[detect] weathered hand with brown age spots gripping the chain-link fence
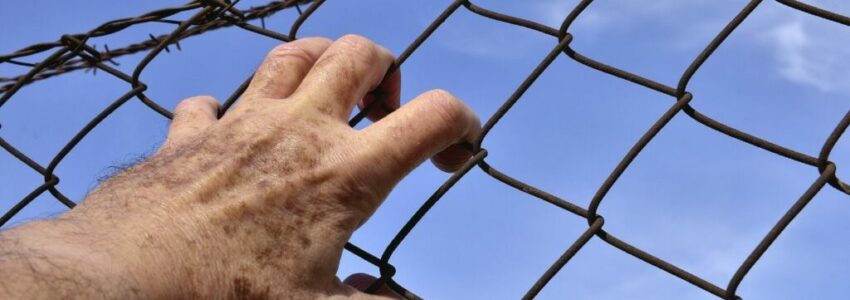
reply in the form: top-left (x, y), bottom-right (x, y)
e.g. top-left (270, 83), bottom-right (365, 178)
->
top-left (0, 35), bottom-right (480, 299)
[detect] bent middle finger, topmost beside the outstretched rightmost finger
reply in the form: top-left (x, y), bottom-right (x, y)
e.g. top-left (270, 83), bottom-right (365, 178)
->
top-left (295, 35), bottom-right (395, 121)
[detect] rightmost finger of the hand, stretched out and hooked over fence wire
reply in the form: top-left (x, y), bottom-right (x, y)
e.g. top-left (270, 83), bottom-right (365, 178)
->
top-left (362, 90), bottom-right (481, 178)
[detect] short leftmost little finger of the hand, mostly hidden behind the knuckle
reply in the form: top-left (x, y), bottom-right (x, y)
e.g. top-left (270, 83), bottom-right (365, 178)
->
top-left (165, 96), bottom-right (219, 145)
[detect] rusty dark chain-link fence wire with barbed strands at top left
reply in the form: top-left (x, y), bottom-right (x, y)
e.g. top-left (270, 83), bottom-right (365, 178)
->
top-left (0, 0), bottom-right (850, 299)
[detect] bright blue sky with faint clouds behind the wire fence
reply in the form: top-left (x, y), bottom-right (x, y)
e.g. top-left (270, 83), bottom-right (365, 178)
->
top-left (0, 0), bottom-right (850, 299)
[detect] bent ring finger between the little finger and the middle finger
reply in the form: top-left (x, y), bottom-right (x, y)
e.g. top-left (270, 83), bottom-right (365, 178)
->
top-left (245, 37), bottom-right (331, 98)
